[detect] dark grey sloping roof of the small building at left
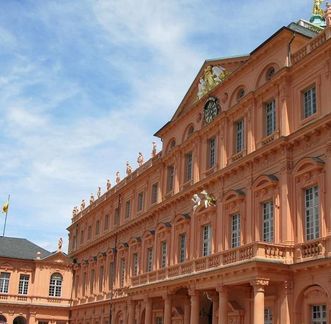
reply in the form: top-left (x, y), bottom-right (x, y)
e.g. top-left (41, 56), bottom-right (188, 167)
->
top-left (0, 236), bottom-right (51, 260)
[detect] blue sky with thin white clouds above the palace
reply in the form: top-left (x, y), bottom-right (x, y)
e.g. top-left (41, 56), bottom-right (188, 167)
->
top-left (0, 0), bottom-right (313, 250)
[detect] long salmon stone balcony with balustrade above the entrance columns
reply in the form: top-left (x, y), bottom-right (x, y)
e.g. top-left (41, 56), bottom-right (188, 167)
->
top-left (131, 237), bottom-right (331, 287)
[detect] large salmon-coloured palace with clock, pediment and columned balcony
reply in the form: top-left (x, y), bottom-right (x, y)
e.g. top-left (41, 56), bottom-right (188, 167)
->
top-left (63, 1), bottom-right (331, 324)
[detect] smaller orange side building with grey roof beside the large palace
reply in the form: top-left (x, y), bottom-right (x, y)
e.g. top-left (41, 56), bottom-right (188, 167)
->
top-left (0, 237), bottom-right (72, 324)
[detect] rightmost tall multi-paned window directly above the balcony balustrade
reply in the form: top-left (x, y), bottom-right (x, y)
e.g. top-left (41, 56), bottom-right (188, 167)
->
top-left (305, 186), bottom-right (319, 240)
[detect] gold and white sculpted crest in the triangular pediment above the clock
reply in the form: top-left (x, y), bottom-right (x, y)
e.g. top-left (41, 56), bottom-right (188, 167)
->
top-left (198, 65), bottom-right (230, 99)
